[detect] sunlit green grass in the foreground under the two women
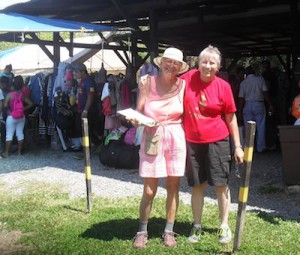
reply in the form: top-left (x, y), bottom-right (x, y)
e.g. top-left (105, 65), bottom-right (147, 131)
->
top-left (0, 184), bottom-right (300, 255)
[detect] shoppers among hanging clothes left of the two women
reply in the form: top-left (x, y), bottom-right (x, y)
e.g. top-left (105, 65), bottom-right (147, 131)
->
top-left (0, 63), bottom-right (136, 158)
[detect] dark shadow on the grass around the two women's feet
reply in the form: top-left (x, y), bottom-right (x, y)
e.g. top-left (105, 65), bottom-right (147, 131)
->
top-left (80, 218), bottom-right (195, 241)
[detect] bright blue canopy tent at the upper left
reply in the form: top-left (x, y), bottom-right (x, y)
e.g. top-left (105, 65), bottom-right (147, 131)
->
top-left (0, 13), bottom-right (115, 67)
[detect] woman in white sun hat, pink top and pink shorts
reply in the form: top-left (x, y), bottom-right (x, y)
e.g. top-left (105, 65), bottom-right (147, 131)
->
top-left (131, 48), bottom-right (188, 248)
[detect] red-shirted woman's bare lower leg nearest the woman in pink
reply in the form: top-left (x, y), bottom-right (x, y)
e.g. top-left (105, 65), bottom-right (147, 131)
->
top-left (191, 182), bottom-right (207, 224)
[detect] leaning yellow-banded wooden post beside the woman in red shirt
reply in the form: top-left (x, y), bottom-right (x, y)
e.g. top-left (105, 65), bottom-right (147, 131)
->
top-left (233, 121), bottom-right (256, 252)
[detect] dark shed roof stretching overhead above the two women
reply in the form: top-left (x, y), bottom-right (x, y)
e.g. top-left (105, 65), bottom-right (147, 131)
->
top-left (1, 0), bottom-right (300, 58)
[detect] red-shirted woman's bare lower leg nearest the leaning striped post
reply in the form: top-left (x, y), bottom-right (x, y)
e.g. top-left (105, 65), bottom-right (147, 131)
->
top-left (215, 186), bottom-right (231, 225)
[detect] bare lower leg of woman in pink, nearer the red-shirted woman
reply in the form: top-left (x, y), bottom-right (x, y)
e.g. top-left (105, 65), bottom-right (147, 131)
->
top-left (166, 176), bottom-right (180, 223)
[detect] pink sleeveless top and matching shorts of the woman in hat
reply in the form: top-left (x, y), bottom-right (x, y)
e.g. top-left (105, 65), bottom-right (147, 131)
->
top-left (139, 77), bottom-right (186, 178)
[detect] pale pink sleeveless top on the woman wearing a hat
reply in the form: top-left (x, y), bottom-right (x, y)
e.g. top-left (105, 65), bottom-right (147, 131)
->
top-left (144, 76), bottom-right (184, 124)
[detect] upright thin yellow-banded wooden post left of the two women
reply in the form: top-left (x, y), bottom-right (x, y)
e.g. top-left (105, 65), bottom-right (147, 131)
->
top-left (81, 118), bottom-right (92, 212)
